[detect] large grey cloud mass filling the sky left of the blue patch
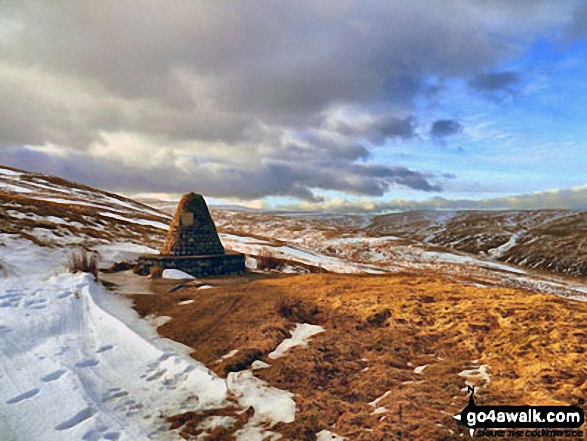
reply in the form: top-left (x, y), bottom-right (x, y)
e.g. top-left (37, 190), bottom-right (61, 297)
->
top-left (0, 0), bottom-right (572, 200)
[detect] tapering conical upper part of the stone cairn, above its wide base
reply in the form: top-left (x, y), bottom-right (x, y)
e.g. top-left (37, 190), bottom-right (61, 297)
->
top-left (161, 193), bottom-right (225, 256)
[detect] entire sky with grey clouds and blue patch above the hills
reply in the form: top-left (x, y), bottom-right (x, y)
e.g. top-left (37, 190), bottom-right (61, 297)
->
top-left (0, 0), bottom-right (587, 210)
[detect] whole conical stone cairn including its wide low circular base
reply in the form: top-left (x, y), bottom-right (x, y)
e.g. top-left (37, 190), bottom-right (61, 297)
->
top-left (138, 193), bottom-right (245, 277)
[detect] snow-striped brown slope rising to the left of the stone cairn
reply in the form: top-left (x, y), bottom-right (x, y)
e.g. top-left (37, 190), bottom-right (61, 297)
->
top-left (0, 167), bottom-right (170, 275)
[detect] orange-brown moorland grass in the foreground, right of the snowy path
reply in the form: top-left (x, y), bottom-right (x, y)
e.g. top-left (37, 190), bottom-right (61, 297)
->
top-left (134, 274), bottom-right (587, 440)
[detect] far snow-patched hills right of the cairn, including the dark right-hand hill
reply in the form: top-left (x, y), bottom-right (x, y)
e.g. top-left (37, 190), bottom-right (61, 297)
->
top-left (214, 210), bottom-right (587, 276)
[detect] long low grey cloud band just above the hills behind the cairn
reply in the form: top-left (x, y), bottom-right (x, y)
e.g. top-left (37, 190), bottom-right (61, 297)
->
top-left (0, 148), bottom-right (442, 202)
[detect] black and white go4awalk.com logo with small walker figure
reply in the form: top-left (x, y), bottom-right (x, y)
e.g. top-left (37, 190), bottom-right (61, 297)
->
top-left (453, 386), bottom-right (585, 439)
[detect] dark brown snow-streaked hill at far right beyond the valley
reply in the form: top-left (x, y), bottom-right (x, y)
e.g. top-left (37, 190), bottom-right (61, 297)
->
top-left (367, 210), bottom-right (587, 276)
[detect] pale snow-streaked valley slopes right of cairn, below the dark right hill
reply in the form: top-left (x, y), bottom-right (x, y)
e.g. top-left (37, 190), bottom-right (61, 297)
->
top-left (213, 210), bottom-right (587, 300)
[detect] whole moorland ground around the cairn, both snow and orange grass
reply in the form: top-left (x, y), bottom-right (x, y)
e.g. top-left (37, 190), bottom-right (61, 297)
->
top-left (0, 167), bottom-right (587, 441)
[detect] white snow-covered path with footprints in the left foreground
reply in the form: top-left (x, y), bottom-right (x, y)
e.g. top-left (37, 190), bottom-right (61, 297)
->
top-left (0, 240), bottom-right (295, 441)
